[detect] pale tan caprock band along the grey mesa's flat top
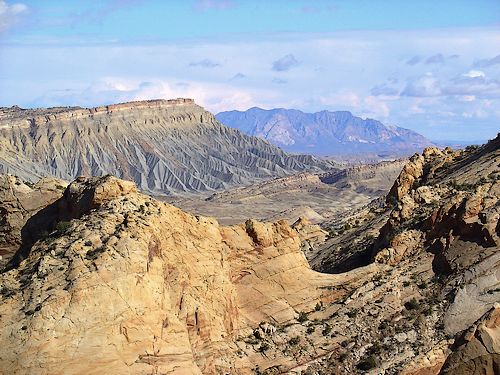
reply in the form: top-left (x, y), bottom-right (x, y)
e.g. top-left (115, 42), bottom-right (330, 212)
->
top-left (0, 98), bottom-right (202, 127)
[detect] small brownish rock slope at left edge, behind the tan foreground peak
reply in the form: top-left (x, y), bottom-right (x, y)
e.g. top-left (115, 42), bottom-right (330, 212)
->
top-left (0, 175), bottom-right (67, 264)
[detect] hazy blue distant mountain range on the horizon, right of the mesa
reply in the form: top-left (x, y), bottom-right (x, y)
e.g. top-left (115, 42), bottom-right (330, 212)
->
top-left (216, 107), bottom-right (432, 156)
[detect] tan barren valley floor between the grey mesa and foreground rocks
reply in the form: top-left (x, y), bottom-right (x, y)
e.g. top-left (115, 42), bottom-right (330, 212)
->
top-left (169, 160), bottom-right (406, 224)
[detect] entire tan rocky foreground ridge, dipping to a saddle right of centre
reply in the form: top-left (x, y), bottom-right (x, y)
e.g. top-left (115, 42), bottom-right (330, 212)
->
top-left (0, 134), bottom-right (500, 374)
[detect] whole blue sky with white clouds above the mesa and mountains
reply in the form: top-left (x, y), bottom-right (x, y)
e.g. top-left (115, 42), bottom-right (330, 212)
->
top-left (0, 0), bottom-right (500, 141)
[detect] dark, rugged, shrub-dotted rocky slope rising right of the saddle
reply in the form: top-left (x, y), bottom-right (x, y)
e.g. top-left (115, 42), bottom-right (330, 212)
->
top-left (302, 137), bottom-right (500, 375)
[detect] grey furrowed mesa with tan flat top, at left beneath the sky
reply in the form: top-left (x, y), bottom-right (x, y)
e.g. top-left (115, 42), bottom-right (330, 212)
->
top-left (0, 99), bottom-right (332, 194)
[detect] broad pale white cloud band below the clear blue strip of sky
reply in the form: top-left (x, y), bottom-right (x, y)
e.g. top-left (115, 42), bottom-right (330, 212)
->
top-left (0, 28), bottom-right (500, 138)
